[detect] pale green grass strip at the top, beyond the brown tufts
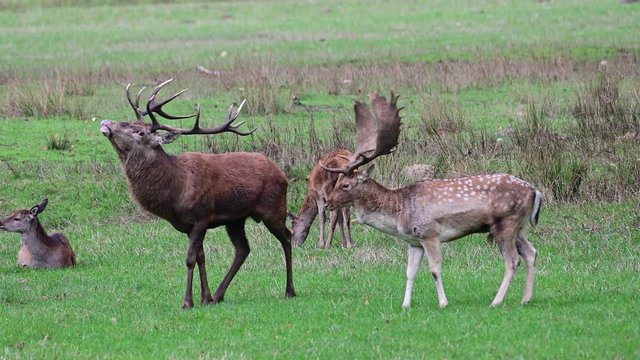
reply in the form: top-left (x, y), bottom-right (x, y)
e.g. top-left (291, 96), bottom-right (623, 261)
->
top-left (0, 0), bottom-right (640, 71)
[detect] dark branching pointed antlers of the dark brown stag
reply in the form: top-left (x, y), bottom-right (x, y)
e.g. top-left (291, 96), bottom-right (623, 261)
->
top-left (126, 79), bottom-right (256, 136)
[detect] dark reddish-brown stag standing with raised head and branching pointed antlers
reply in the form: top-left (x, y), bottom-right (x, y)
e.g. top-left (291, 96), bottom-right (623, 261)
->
top-left (100, 79), bottom-right (296, 308)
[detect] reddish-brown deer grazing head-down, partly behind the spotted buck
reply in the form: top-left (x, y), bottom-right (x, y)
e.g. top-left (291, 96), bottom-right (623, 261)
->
top-left (291, 149), bottom-right (353, 249)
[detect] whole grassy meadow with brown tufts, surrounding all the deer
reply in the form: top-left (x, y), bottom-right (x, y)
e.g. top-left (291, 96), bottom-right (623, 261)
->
top-left (0, 0), bottom-right (640, 359)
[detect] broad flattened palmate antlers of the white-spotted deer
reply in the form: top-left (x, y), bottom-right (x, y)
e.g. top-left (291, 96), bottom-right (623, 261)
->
top-left (320, 92), bottom-right (402, 175)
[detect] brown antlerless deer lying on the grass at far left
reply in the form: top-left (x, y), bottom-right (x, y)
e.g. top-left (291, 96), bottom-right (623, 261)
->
top-left (0, 199), bottom-right (76, 268)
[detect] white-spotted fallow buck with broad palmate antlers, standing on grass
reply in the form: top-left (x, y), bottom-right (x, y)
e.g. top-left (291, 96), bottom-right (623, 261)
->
top-left (323, 93), bottom-right (542, 308)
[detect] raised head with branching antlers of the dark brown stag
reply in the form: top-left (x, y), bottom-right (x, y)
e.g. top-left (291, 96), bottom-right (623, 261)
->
top-left (100, 79), bottom-right (255, 157)
